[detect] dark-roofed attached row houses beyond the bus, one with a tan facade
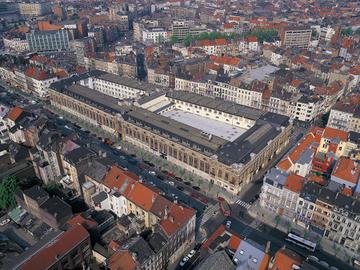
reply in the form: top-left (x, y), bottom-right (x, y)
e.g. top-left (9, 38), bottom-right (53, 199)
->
top-left (296, 182), bottom-right (360, 253)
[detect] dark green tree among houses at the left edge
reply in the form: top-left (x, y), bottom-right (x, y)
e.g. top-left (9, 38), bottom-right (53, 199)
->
top-left (0, 176), bottom-right (18, 209)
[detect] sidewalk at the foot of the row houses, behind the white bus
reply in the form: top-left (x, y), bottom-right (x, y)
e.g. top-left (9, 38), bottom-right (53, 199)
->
top-left (248, 202), bottom-right (359, 265)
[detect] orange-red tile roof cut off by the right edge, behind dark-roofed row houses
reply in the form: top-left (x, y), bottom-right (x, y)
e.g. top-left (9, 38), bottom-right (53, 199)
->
top-left (331, 157), bottom-right (360, 185)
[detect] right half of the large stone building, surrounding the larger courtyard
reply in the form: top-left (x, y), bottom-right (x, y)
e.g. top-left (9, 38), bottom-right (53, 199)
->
top-left (122, 91), bottom-right (291, 194)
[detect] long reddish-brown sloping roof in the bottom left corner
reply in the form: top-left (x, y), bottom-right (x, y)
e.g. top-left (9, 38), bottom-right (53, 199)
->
top-left (20, 225), bottom-right (90, 270)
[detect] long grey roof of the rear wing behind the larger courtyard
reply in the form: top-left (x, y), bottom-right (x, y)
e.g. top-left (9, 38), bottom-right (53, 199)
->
top-left (166, 91), bottom-right (263, 120)
